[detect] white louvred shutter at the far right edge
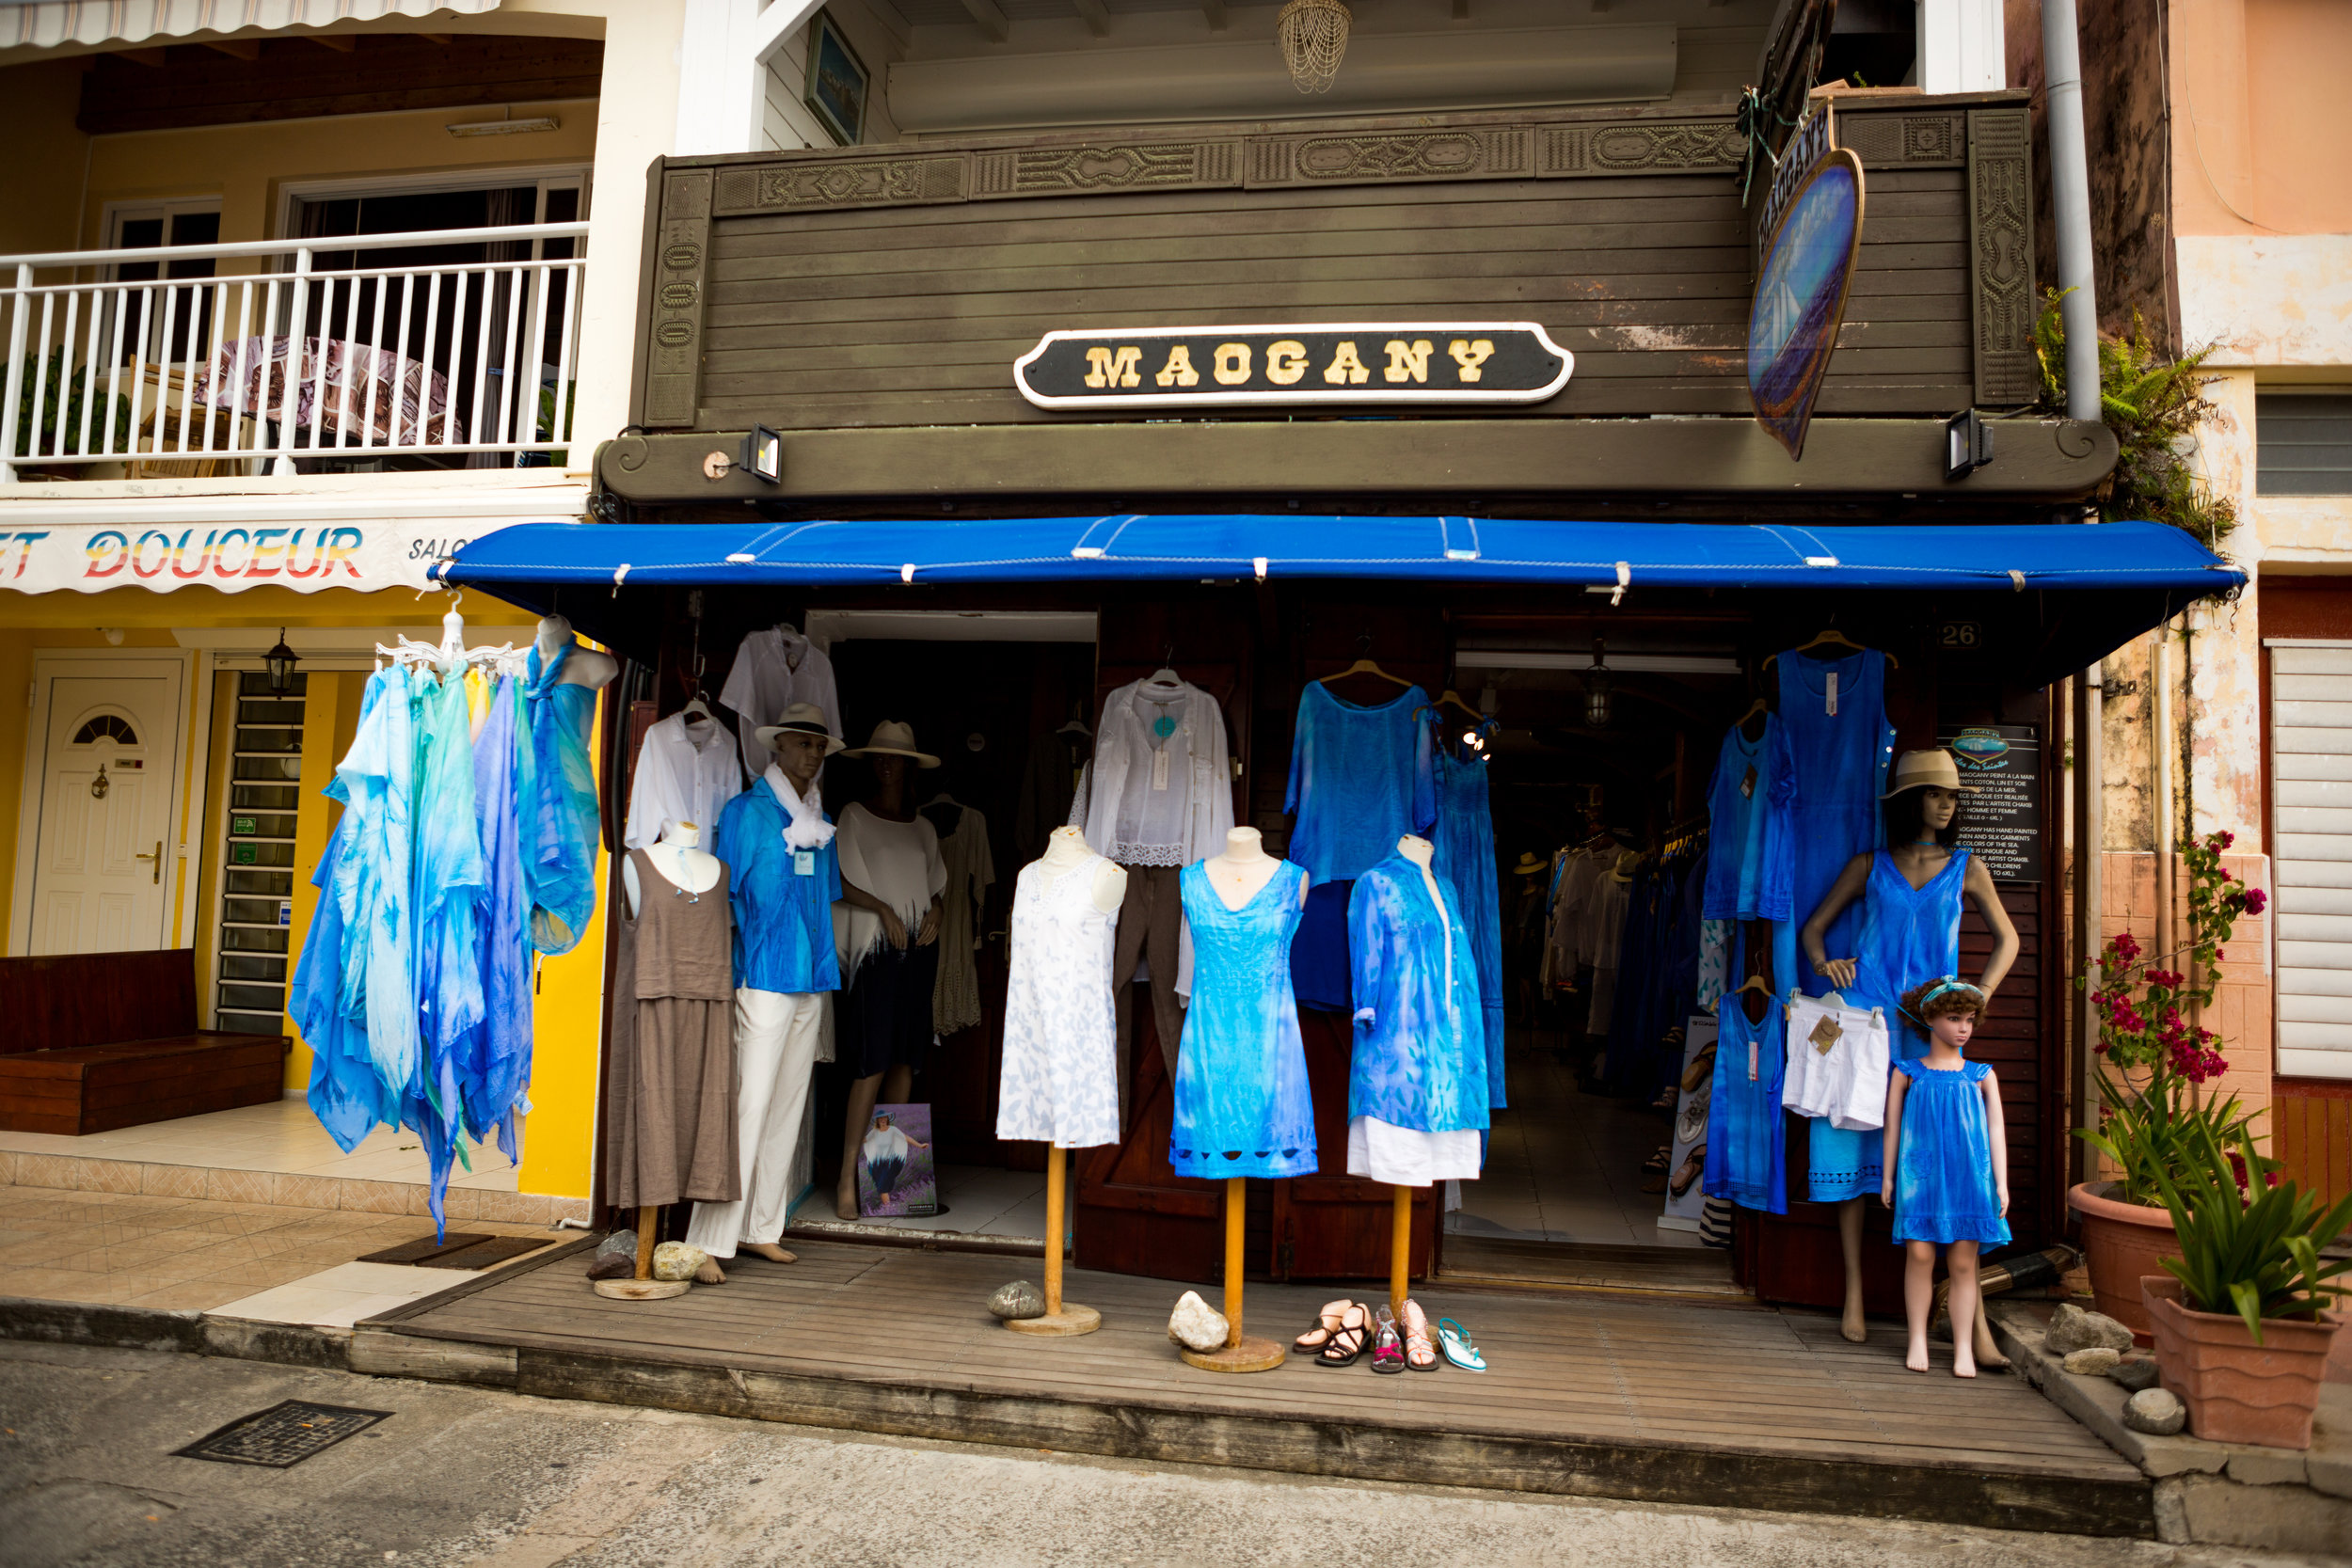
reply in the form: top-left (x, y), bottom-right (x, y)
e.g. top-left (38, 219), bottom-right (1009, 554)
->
top-left (2270, 641), bottom-right (2352, 1079)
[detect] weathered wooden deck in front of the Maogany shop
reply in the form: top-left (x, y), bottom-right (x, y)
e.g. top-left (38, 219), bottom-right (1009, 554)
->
top-left (356, 1243), bottom-right (2153, 1535)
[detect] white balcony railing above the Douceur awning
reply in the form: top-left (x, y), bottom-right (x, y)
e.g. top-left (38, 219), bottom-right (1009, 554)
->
top-left (0, 223), bottom-right (588, 482)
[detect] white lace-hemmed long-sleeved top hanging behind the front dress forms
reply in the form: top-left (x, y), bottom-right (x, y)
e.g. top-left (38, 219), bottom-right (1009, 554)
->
top-left (1080, 679), bottom-right (1232, 865)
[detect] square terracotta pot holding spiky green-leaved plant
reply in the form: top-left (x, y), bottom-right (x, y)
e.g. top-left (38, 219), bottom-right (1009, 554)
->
top-left (2140, 1275), bottom-right (2338, 1449)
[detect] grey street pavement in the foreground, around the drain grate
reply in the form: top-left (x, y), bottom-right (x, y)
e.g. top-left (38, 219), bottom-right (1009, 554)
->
top-left (0, 1342), bottom-right (2305, 1568)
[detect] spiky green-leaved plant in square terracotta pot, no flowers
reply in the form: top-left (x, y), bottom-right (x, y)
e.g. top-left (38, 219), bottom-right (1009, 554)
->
top-left (2140, 1129), bottom-right (2352, 1449)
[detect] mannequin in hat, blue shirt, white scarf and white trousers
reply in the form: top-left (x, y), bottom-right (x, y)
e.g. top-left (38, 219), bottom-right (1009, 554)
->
top-left (687, 703), bottom-right (842, 1284)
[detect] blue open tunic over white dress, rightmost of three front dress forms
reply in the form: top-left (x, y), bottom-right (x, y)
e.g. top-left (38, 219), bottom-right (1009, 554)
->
top-left (1348, 853), bottom-right (1486, 1133)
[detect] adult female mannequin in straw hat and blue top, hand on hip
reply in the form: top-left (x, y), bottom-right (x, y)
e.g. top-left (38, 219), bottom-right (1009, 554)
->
top-left (1800, 748), bottom-right (2018, 1366)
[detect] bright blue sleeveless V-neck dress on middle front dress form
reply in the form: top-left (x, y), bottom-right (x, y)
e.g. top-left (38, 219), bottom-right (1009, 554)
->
top-left (1169, 861), bottom-right (1315, 1180)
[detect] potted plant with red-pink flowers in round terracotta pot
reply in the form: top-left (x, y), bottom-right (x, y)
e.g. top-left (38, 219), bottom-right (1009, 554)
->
top-left (2068, 832), bottom-right (2275, 1342)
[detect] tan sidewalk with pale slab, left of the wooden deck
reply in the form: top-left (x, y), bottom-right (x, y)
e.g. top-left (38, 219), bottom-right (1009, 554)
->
top-left (0, 1185), bottom-right (563, 1323)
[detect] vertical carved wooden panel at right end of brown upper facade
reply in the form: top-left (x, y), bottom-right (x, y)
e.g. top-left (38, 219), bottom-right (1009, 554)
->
top-left (1966, 108), bottom-right (2042, 404)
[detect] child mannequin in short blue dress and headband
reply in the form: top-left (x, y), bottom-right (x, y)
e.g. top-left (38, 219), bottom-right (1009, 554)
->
top-left (1880, 975), bottom-right (2009, 1378)
